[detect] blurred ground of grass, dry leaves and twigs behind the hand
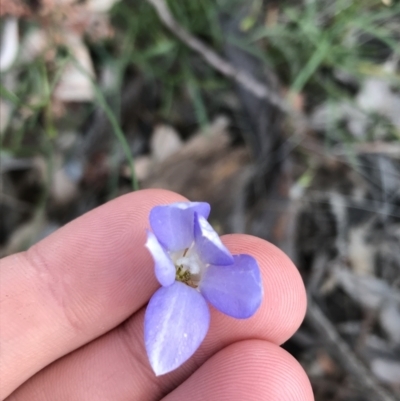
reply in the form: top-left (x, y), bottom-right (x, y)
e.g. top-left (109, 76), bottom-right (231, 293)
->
top-left (0, 0), bottom-right (400, 401)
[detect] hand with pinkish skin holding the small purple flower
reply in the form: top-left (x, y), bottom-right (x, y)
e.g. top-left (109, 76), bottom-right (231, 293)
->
top-left (0, 190), bottom-right (314, 401)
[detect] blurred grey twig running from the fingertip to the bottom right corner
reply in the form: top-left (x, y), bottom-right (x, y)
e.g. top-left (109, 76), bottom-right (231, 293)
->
top-left (307, 297), bottom-right (399, 401)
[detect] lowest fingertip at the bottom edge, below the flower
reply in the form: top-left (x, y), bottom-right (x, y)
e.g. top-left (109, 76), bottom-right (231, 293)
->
top-left (162, 340), bottom-right (314, 401)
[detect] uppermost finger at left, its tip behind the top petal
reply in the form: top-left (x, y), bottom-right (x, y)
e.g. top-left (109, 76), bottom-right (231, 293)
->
top-left (0, 190), bottom-right (188, 398)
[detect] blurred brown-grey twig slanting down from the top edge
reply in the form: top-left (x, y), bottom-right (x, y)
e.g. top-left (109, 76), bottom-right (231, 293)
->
top-left (147, 0), bottom-right (293, 114)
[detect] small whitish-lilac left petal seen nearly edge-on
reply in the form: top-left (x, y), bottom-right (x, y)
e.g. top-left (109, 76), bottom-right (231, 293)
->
top-left (146, 231), bottom-right (176, 287)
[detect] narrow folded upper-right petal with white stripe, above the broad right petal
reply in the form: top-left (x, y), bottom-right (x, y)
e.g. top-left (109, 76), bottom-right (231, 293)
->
top-left (194, 213), bottom-right (233, 266)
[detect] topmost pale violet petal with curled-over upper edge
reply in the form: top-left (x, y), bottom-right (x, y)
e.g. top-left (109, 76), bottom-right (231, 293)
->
top-left (150, 202), bottom-right (210, 251)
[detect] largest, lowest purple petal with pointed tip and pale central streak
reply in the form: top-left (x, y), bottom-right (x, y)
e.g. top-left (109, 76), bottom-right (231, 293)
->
top-left (144, 281), bottom-right (210, 376)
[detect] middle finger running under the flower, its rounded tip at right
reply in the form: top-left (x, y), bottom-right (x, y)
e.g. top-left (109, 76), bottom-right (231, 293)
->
top-left (7, 235), bottom-right (306, 401)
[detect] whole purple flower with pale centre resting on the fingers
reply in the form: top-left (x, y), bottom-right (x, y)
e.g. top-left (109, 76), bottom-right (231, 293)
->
top-left (144, 202), bottom-right (263, 376)
